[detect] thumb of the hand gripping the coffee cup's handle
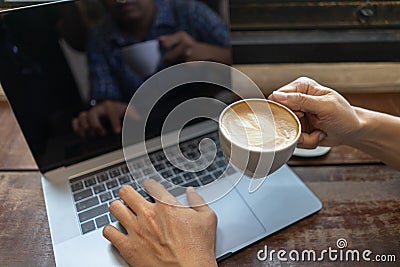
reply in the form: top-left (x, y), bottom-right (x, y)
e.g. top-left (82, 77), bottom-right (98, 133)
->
top-left (270, 91), bottom-right (321, 114)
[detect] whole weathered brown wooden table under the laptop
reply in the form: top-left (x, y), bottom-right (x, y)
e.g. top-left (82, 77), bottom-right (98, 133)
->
top-left (0, 93), bottom-right (400, 266)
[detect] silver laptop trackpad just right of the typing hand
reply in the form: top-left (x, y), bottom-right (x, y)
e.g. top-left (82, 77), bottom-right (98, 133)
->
top-left (210, 189), bottom-right (265, 258)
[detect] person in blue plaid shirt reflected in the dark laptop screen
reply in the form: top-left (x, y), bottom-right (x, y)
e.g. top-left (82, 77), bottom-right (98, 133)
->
top-left (72, 0), bottom-right (230, 137)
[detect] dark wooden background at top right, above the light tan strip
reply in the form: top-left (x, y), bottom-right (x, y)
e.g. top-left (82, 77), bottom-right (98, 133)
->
top-left (229, 0), bottom-right (400, 64)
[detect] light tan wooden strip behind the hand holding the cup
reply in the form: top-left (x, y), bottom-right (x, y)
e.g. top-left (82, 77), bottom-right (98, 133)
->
top-left (234, 62), bottom-right (400, 94)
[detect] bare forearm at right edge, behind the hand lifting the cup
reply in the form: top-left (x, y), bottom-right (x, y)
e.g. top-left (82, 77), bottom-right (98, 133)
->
top-left (350, 108), bottom-right (400, 170)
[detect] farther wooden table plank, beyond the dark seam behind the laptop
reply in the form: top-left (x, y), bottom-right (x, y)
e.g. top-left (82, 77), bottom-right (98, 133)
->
top-left (0, 93), bottom-right (400, 170)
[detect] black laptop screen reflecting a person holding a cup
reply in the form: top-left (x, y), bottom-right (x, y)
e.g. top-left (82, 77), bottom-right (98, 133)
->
top-left (0, 0), bottom-right (230, 172)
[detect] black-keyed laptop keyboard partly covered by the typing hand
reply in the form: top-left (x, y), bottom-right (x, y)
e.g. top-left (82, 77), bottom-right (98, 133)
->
top-left (70, 132), bottom-right (236, 234)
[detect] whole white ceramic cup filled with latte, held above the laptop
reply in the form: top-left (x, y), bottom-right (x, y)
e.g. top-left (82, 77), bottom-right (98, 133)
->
top-left (219, 98), bottom-right (301, 178)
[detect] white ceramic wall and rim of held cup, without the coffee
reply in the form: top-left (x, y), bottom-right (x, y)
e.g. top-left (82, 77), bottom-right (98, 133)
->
top-left (219, 99), bottom-right (301, 178)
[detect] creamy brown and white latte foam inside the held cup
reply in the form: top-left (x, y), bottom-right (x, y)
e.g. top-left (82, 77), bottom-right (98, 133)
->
top-left (221, 100), bottom-right (298, 150)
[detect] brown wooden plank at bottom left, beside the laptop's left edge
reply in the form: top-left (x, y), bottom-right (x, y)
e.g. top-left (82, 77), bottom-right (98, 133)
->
top-left (0, 172), bottom-right (55, 266)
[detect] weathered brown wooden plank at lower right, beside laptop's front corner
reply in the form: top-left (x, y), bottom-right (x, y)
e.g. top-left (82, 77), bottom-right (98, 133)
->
top-left (220, 165), bottom-right (400, 267)
